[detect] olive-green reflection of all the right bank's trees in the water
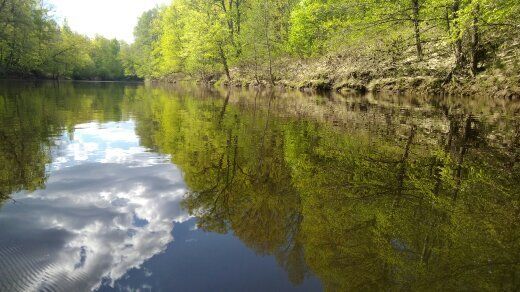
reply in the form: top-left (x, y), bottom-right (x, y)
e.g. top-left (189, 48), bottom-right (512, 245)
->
top-left (138, 90), bottom-right (520, 291)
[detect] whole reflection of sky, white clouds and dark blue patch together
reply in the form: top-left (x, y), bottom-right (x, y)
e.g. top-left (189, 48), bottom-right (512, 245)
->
top-left (0, 121), bottom-right (320, 291)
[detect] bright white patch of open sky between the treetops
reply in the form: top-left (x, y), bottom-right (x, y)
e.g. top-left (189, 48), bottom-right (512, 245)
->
top-left (47, 0), bottom-right (171, 42)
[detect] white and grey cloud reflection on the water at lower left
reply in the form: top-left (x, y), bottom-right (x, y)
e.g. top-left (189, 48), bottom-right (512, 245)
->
top-left (0, 122), bottom-right (188, 291)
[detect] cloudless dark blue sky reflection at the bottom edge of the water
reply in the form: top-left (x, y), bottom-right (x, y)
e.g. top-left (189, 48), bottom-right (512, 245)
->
top-left (100, 219), bottom-right (321, 292)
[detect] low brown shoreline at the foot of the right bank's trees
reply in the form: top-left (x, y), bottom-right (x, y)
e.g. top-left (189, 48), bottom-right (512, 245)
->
top-left (146, 60), bottom-right (520, 100)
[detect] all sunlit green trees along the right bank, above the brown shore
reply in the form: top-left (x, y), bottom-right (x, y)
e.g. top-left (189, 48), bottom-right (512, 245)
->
top-left (128, 0), bottom-right (520, 81)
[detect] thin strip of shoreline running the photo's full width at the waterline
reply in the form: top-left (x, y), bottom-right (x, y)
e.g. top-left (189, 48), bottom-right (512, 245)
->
top-left (0, 62), bottom-right (520, 100)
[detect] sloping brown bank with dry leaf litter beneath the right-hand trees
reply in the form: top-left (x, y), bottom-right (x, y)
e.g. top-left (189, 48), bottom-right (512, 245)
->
top-left (214, 46), bottom-right (520, 99)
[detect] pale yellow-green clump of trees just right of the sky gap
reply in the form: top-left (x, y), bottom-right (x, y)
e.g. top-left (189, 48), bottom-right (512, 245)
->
top-left (130, 0), bottom-right (294, 78)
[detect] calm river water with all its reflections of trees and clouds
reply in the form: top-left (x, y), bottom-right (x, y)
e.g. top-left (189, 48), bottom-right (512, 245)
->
top-left (0, 82), bottom-right (520, 291)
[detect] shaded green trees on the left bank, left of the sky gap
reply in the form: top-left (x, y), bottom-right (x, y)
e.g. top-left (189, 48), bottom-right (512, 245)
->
top-left (0, 0), bottom-right (133, 80)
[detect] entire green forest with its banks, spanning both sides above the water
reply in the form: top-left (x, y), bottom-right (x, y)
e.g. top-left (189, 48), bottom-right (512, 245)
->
top-left (0, 0), bottom-right (520, 96)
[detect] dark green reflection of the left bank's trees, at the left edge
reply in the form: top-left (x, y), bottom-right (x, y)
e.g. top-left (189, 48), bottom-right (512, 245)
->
top-left (0, 82), bottom-right (129, 206)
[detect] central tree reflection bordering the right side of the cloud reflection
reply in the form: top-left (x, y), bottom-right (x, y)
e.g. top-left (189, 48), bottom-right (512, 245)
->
top-left (134, 90), bottom-right (306, 282)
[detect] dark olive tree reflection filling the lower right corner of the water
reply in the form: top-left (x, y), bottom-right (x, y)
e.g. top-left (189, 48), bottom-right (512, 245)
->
top-left (288, 111), bottom-right (520, 290)
